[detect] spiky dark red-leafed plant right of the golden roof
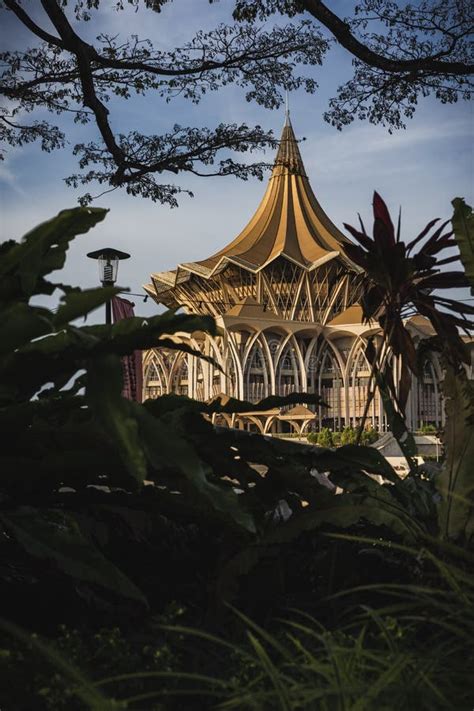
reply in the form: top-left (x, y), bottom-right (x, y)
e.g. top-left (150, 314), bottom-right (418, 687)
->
top-left (344, 192), bottom-right (474, 406)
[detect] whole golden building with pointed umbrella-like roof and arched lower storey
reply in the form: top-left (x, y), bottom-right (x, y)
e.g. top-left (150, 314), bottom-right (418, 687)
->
top-left (144, 118), bottom-right (444, 434)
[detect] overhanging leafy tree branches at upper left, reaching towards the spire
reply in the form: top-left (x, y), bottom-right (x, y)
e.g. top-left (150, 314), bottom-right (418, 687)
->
top-left (1, 0), bottom-right (328, 206)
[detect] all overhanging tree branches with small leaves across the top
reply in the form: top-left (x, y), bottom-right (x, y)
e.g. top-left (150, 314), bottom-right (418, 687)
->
top-left (0, 0), bottom-right (473, 206)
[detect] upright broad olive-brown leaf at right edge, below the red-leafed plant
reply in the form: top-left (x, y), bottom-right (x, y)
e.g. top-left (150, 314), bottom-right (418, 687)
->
top-left (437, 363), bottom-right (474, 540)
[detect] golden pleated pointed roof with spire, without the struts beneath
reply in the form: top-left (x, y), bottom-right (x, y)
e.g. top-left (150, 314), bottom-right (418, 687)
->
top-left (180, 117), bottom-right (348, 276)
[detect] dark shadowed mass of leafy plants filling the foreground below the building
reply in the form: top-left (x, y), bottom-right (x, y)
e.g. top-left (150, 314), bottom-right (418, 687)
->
top-left (0, 201), bottom-right (474, 711)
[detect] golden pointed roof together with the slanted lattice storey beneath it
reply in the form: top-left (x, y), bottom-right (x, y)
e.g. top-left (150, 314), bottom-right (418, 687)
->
top-left (145, 113), bottom-right (357, 323)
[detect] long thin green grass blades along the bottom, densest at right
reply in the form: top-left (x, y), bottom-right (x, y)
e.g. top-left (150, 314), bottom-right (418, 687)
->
top-left (3, 534), bottom-right (474, 711)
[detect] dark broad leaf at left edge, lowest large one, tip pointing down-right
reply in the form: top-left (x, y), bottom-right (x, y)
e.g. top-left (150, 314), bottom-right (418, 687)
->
top-left (0, 507), bottom-right (147, 605)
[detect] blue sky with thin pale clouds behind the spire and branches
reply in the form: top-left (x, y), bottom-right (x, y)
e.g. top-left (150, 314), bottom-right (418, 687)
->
top-left (0, 0), bottom-right (474, 323)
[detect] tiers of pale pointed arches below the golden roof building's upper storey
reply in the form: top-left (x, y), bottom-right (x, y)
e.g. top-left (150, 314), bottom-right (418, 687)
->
top-left (144, 324), bottom-right (444, 434)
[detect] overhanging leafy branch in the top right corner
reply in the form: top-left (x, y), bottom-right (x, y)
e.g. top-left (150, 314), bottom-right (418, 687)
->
top-left (234, 0), bottom-right (474, 130)
